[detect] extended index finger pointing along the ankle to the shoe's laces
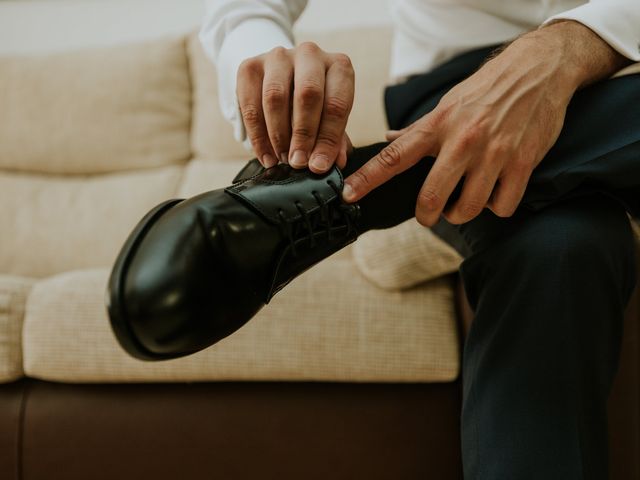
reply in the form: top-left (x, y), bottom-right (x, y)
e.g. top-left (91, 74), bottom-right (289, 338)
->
top-left (342, 129), bottom-right (435, 203)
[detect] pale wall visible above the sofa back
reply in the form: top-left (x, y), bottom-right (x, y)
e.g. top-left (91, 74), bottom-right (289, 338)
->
top-left (0, 0), bottom-right (389, 54)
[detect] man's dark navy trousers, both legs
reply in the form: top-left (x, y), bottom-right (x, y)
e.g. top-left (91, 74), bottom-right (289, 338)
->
top-left (356, 48), bottom-right (640, 480)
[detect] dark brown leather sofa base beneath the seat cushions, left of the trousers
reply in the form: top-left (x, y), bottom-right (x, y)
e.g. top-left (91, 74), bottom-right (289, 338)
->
top-left (0, 380), bottom-right (462, 480)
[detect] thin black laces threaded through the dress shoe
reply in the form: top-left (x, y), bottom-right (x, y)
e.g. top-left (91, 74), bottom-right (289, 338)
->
top-left (278, 180), bottom-right (354, 257)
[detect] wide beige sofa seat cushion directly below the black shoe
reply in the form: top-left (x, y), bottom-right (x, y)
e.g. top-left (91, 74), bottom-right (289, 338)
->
top-left (24, 264), bottom-right (459, 382)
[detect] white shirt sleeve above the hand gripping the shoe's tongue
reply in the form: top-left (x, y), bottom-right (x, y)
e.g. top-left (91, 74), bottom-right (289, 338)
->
top-left (199, 0), bottom-right (307, 150)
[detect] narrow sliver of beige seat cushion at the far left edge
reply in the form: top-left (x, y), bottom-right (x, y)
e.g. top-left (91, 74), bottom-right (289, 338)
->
top-left (0, 275), bottom-right (33, 383)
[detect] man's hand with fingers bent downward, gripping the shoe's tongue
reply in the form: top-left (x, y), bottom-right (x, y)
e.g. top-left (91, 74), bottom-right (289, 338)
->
top-left (236, 42), bottom-right (355, 173)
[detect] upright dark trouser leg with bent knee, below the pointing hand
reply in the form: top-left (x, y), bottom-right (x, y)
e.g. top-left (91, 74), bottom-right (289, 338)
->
top-left (448, 195), bottom-right (635, 480)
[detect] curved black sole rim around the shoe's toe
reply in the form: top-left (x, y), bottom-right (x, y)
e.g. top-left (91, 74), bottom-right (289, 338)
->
top-left (105, 199), bottom-right (182, 360)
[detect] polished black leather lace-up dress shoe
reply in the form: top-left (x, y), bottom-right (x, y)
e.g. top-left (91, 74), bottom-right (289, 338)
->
top-left (107, 160), bottom-right (359, 360)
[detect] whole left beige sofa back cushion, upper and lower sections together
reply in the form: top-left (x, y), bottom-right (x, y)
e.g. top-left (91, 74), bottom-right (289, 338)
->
top-left (0, 36), bottom-right (191, 277)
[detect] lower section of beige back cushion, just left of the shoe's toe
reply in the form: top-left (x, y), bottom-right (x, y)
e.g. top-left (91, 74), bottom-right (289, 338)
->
top-left (0, 167), bottom-right (182, 277)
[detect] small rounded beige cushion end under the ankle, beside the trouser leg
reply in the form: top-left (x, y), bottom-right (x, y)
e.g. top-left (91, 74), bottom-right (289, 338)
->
top-left (353, 218), bottom-right (462, 290)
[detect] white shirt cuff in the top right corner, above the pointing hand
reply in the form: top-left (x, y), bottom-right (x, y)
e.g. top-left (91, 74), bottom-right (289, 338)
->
top-left (544, 0), bottom-right (640, 62)
